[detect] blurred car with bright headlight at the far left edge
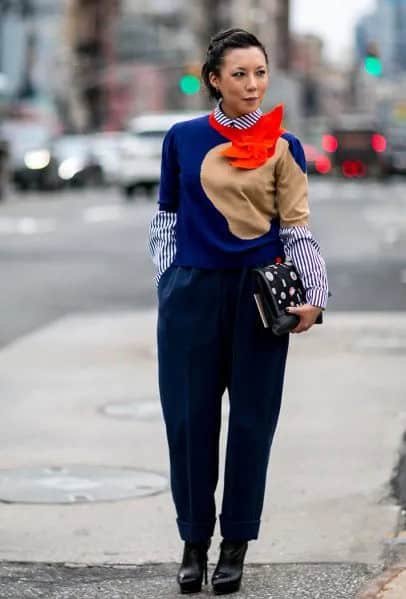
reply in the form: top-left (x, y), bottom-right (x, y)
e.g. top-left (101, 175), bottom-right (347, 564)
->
top-left (2, 120), bottom-right (59, 190)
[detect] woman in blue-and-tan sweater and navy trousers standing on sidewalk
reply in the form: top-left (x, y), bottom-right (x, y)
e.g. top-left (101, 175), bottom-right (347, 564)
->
top-left (150, 29), bottom-right (328, 594)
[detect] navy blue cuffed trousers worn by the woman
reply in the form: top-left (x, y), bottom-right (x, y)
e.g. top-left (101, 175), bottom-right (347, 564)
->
top-left (158, 266), bottom-right (289, 542)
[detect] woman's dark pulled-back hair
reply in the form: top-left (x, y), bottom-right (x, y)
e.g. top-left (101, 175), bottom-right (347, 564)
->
top-left (201, 29), bottom-right (268, 100)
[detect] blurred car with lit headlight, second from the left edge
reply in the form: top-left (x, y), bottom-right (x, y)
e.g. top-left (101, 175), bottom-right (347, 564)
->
top-left (50, 134), bottom-right (103, 187)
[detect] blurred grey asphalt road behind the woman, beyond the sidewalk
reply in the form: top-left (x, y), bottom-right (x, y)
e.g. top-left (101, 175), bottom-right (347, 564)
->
top-left (0, 178), bottom-right (406, 347)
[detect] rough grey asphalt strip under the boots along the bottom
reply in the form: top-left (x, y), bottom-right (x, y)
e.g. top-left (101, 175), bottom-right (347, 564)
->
top-left (0, 564), bottom-right (380, 599)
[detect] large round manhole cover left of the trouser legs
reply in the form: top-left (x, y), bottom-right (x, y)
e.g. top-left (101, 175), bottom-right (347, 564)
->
top-left (0, 466), bottom-right (168, 503)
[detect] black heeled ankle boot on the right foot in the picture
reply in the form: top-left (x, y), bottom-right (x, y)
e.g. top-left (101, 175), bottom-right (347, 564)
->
top-left (211, 539), bottom-right (248, 595)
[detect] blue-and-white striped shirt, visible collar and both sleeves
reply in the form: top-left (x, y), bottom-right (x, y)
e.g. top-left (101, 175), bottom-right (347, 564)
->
top-left (149, 103), bottom-right (329, 309)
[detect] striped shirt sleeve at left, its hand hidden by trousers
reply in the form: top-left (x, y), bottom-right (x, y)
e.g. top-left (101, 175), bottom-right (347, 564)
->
top-left (148, 210), bottom-right (176, 285)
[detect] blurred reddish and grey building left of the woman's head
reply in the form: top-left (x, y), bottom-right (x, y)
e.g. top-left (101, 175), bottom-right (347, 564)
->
top-left (59, 0), bottom-right (200, 130)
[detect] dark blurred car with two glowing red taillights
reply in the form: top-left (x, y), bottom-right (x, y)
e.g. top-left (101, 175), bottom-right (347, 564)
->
top-left (322, 114), bottom-right (388, 178)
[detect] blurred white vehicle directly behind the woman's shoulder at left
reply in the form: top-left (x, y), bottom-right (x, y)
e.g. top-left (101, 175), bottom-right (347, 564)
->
top-left (117, 112), bottom-right (206, 199)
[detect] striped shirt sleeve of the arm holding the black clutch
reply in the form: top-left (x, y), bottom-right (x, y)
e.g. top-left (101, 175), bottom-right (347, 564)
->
top-left (279, 226), bottom-right (329, 309)
